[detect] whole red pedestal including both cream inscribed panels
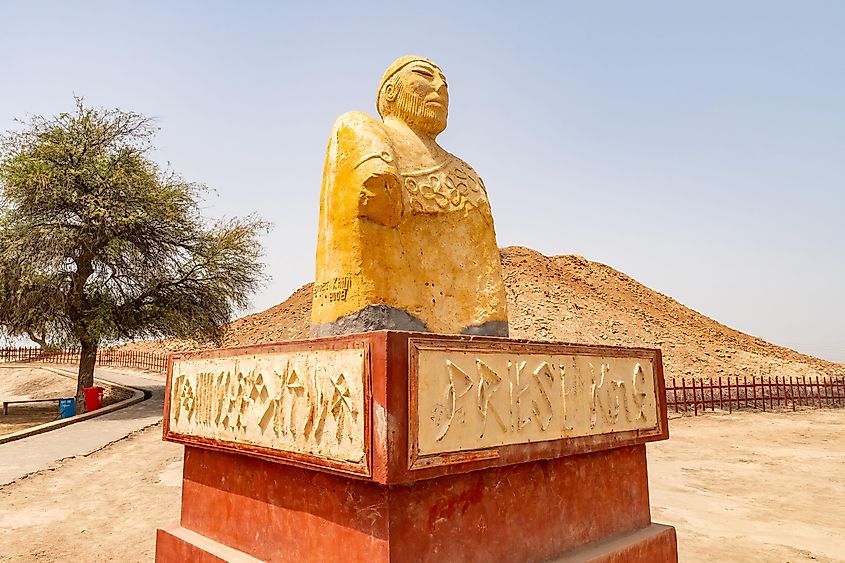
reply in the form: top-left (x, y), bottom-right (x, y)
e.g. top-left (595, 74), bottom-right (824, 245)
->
top-left (156, 332), bottom-right (677, 563)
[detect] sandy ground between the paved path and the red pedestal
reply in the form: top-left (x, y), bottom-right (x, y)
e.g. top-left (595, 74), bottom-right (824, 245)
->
top-left (0, 424), bottom-right (182, 563)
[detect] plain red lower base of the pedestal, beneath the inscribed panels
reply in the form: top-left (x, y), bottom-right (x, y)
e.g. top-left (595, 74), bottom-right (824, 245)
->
top-left (156, 446), bottom-right (676, 563)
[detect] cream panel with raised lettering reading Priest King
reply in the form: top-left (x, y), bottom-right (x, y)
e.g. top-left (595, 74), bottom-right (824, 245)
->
top-left (417, 349), bottom-right (658, 455)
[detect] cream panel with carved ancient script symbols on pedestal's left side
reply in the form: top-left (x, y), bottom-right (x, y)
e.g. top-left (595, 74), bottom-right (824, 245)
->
top-left (170, 349), bottom-right (366, 463)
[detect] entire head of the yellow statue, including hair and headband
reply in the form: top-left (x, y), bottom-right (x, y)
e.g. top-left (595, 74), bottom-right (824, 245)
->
top-left (376, 55), bottom-right (449, 138)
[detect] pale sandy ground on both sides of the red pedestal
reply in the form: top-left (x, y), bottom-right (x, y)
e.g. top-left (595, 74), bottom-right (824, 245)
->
top-left (0, 410), bottom-right (845, 562)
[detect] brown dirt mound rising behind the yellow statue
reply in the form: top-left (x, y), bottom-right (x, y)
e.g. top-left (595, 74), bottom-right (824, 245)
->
top-left (120, 246), bottom-right (845, 377)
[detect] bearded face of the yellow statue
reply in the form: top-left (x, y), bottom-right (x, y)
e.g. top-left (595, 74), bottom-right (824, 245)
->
top-left (390, 61), bottom-right (449, 137)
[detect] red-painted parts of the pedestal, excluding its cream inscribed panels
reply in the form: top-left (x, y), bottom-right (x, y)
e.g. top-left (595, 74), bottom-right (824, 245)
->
top-left (156, 332), bottom-right (677, 563)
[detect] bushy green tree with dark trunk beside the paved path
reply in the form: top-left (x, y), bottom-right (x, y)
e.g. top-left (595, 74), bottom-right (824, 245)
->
top-left (0, 98), bottom-right (267, 412)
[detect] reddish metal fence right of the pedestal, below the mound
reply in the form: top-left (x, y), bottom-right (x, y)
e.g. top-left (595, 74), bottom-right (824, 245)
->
top-left (666, 376), bottom-right (845, 415)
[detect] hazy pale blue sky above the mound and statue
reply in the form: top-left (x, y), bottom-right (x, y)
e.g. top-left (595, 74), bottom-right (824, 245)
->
top-left (0, 0), bottom-right (845, 361)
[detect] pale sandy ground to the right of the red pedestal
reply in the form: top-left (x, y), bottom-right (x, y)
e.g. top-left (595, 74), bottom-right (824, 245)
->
top-left (648, 409), bottom-right (845, 562)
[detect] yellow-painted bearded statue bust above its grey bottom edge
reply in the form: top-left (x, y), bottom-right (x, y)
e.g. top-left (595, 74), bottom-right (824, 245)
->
top-left (312, 58), bottom-right (507, 333)
